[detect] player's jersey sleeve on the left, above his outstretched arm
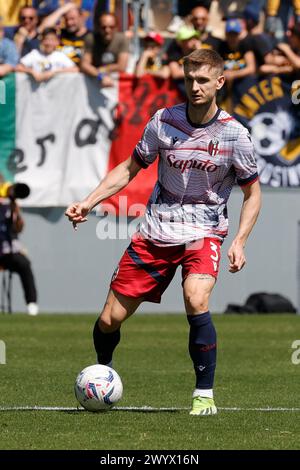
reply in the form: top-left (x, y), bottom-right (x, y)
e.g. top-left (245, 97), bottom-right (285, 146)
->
top-left (132, 113), bottom-right (159, 168)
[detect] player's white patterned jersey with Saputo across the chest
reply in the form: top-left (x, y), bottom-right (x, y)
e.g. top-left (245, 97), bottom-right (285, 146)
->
top-left (133, 103), bottom-right (258, 246)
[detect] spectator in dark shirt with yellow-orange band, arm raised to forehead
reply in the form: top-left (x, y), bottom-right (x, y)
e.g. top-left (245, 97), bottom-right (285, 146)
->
top-left (41, 2), bottom-right (91, 66)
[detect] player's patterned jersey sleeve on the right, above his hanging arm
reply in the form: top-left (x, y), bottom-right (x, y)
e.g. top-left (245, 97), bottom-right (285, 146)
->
top-left (233, 129), bottom-right (258, 186)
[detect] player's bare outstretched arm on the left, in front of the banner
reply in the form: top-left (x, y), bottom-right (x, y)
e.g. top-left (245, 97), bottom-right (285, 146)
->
top-left (65, 157), bottom-right (141, 229)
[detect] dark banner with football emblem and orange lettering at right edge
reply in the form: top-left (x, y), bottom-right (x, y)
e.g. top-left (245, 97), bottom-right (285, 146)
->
top-left (233, 76), bottom-right (300, 188)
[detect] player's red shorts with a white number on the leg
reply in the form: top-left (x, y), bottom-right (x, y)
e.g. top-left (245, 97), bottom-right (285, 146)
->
top-left (111, 237), bottom-right (221, 303)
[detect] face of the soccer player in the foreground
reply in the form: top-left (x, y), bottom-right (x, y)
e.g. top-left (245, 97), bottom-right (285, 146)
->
top-left (185, 65), bottom-right (225, 106)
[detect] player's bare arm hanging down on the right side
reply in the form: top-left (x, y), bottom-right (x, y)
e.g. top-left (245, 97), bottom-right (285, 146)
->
top-left (228, 181), bottom-right (261, 273)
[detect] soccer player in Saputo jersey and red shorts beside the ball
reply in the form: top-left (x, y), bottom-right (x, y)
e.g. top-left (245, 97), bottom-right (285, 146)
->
top-left (66, 49), bottom-right (261, 416)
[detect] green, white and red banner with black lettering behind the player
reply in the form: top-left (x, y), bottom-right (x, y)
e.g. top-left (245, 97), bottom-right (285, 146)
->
top-left (0, 74), bottom-right (178, 212)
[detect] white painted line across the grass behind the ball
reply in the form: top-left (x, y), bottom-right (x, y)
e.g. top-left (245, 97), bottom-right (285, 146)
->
top-left (0, 406), bottom-right (300, 411)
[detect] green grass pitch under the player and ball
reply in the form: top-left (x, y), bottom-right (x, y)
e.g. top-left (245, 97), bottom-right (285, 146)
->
top-left (0, 314), bottom-right (300, 450)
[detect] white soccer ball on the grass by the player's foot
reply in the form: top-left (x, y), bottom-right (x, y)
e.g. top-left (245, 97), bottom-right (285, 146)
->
top-left (75, 364), bottom-right (123, 411)
